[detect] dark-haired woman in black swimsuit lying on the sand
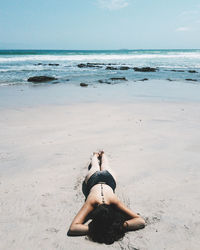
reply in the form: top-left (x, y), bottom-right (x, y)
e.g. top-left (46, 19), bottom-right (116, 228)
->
top-left (68, 151), bottom-right (145, 244)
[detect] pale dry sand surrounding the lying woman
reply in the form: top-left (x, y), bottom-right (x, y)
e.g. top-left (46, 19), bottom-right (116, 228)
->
top-left (0, 102), bottom-right (200, 250)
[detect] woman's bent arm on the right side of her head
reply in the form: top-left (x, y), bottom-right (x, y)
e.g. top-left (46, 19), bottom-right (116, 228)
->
top-left (115, 199), bottom-right (145, 231)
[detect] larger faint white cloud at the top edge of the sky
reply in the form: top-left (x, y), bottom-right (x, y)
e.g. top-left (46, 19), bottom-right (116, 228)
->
top-left (97, 0), bottom-right (129, 10)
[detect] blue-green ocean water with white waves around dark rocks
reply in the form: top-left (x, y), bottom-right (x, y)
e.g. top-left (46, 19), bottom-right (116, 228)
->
top-left (0, 49), bottom-right (200, 87)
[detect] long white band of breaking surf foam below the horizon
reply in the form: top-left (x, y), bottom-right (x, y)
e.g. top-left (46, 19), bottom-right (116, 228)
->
top-left (0, 52), bottom-right (200, 63)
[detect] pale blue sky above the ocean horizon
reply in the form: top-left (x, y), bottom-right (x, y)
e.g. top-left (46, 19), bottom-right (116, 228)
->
top-left (0, 0), bottom-right (200, 49)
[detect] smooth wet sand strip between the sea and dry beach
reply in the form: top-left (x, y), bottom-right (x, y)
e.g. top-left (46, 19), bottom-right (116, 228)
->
top-left (0, 80), bottom-right (200, 108)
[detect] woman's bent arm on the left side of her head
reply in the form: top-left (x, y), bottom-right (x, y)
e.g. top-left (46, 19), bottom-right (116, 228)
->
top-left (67, 201), bottom-right (93, 236)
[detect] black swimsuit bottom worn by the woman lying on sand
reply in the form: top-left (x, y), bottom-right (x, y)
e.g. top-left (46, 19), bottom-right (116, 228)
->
top-left (82, 170), bottom-right (116, 198)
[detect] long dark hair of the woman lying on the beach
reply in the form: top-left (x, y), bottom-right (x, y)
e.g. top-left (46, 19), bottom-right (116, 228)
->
top-left (88, 204), bottom-right (126, 245)
